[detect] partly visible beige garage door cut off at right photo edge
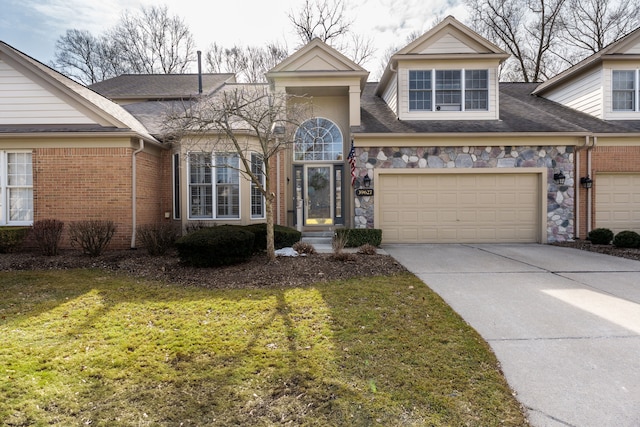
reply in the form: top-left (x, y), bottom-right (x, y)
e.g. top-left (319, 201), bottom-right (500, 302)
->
top-left (594, 173), bottom-right (640, 233)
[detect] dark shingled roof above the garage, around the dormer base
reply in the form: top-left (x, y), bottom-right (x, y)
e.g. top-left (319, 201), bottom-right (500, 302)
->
top-left (354, 83), bottom-right (640, 135)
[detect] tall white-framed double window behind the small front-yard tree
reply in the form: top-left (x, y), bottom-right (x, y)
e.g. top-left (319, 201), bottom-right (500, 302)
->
top-left (189, 153), bottom-right (240, 219)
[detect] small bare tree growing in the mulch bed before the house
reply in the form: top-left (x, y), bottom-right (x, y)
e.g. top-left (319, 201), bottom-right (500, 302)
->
top-left (165, 84), bottom-right (310, 260)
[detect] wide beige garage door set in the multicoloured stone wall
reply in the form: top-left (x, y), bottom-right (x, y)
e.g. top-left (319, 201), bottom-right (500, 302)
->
top-left (376, 173), bottom-right (541, 243)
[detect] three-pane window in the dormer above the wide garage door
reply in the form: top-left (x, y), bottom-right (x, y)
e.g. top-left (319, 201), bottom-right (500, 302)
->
top-left (409, 70), bottom-right (489, 111)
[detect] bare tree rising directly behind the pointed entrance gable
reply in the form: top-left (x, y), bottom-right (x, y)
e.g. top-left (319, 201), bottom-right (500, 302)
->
top-left (288, 0), bottom-right (375, 65)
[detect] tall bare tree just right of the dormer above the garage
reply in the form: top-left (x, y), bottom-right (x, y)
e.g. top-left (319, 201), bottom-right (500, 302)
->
top-left (466, 0), bottom-right (566, 82)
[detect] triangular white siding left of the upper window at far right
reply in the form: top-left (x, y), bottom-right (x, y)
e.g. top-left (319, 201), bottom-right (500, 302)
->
top-left (545, 68), bottom-right (604, 118)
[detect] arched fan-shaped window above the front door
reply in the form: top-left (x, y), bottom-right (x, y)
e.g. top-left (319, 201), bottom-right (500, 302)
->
top-left (293, 117), bottom-right (343, 161)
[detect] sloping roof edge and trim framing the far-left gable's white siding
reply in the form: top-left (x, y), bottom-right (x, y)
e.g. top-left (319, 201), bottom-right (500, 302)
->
top-left (0, 41), bottom-right (158, 142)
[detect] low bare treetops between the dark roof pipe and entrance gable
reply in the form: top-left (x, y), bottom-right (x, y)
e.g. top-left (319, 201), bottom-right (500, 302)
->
top-left (205, 43), bottom-right (288, 83)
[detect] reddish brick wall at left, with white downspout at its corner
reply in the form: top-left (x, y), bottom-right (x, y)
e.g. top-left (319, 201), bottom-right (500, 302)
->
top-left (33, 148), bottom-right (164, 249)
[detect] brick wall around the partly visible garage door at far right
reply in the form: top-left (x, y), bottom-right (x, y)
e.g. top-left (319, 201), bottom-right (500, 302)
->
top-left (576, 146), bottom-right (640, 239)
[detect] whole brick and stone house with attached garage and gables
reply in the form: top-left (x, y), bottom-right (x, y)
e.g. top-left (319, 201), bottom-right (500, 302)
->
top-left (0, 17), bottom-right (640, 248)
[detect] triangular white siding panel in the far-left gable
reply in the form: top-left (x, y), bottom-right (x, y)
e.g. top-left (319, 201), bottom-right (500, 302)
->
top-left (0, 60), bottom-right (95, 125)
